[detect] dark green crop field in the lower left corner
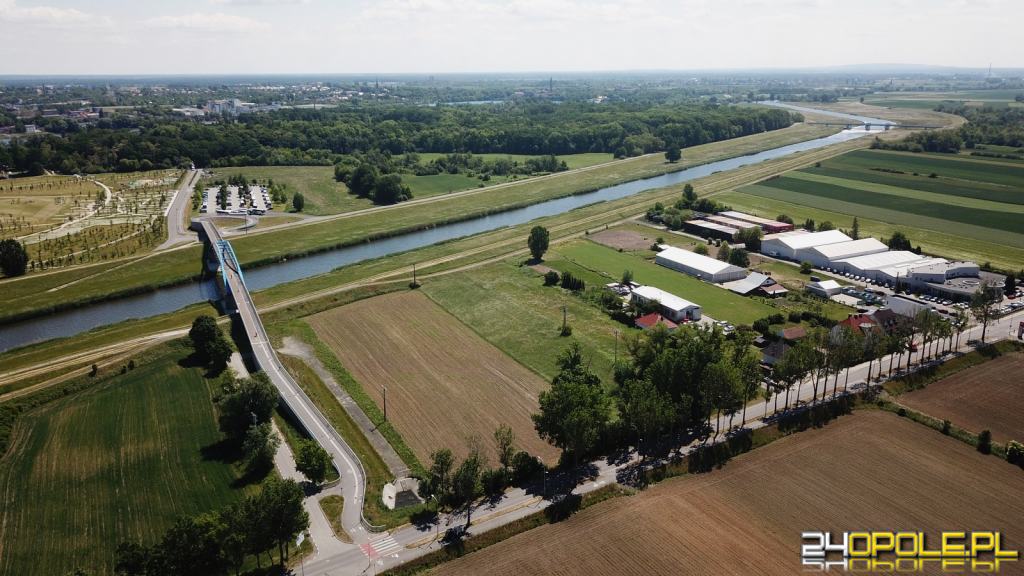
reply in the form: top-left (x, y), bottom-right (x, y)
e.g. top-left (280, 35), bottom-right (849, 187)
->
top-left (0, 346), bottom-right (245, 574)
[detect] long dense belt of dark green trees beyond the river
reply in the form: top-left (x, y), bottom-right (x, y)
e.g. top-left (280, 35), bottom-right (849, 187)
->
top-left (0, 101), bottom-right (799, 173)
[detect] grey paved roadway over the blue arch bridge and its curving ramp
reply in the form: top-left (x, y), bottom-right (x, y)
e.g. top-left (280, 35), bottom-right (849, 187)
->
top-left (197, 220), bottom-right (371, 548)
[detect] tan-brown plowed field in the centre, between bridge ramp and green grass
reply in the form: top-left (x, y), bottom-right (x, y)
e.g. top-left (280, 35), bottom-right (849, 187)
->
top-left (309, 292), bottom-right (558, 464)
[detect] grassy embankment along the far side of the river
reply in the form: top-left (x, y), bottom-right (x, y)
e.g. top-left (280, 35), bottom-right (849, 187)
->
top-left (0, 124), bottom-right (834, 322)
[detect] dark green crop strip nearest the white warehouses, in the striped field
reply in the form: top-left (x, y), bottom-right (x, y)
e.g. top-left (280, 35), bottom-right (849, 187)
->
top-left (737, 177), bottom-right (1024, 248)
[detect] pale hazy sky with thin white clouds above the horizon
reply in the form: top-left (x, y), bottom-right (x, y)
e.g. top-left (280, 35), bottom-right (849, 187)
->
top-left (0, 0), bottom-right (1024, 75)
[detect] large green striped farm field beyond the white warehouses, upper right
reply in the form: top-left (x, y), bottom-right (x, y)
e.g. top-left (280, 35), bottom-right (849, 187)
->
top-left (720, 151), bottom-right (1024, 268)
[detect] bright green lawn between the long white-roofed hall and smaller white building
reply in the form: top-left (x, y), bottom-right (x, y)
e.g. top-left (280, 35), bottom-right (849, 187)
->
top-left (549, 241), bottom-right (775, 324)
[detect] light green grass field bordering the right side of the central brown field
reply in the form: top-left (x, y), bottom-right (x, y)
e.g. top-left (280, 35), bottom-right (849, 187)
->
top-left (421, 262), bottom-right (632, 384)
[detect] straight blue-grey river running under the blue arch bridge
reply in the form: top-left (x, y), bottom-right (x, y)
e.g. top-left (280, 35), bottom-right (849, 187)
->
top-left (0, 107), bottom-right (892, 352)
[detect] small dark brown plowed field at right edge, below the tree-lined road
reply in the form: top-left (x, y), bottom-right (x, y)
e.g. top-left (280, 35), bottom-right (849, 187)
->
top-left (899, 354), bottom-right (1024, 442)
